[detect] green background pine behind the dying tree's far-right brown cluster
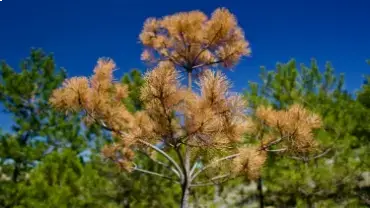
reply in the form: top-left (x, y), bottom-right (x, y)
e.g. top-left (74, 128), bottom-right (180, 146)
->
top-left (246, 60), bottom-right (368, 207)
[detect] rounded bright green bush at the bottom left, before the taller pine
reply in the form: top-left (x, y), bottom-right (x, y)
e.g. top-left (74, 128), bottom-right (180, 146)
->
top-left (18, 149), bottom-right (118, 208)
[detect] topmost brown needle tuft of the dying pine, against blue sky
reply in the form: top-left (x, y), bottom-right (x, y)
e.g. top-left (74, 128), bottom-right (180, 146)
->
top-left (140, 8), bottom-right (251, 71)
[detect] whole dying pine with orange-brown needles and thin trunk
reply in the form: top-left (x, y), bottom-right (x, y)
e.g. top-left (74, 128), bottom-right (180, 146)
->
top-left (51, 8), bottom-right (321, 207)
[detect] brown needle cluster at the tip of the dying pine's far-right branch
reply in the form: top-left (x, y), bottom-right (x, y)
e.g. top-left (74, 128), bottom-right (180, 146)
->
top-left (256, 104), bottom-right (322, 153)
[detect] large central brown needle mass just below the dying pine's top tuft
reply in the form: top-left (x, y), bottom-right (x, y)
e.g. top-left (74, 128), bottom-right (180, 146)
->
top-left (141, 62), bottom-right (249, 148)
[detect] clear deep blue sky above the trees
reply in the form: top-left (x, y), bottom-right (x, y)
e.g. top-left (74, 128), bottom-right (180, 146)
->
top-left (0, 0), bottom-right (370, 130)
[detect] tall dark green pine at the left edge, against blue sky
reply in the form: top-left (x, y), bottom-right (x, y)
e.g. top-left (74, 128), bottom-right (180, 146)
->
top-left (0, 49), bottom-right (102, 207)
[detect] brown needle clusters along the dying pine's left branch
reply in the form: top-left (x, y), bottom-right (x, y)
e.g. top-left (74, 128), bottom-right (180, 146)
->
top-left (50, 58), bottom-right (153, 171)
